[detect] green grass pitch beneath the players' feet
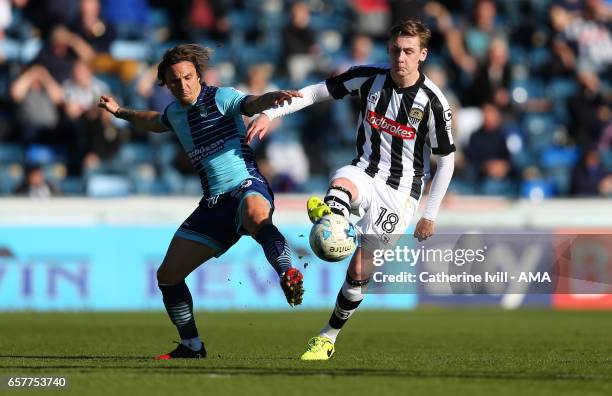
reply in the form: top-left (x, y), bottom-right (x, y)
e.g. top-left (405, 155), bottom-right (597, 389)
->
top-left (0, 309), bottom-right (612, 396)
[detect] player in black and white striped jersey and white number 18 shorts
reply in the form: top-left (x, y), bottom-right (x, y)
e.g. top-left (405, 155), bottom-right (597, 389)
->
top-left (247, 20), bottom-right (455, 360)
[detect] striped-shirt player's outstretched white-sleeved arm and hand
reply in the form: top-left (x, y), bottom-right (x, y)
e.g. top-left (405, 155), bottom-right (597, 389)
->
top-left (246, 82), bottom-right (331, 143)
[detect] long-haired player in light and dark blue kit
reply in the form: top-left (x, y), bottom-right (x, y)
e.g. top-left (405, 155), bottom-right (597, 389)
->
top-left (98, 44), bottom-right (303, 359)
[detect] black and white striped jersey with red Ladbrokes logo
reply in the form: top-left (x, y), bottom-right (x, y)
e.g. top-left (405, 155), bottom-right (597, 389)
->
top-left (325, 65), bottom-right (455, 200)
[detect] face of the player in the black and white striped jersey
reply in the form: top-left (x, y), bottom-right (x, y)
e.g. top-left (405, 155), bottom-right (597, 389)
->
top-left (388, 36), bottom-right (427, 78)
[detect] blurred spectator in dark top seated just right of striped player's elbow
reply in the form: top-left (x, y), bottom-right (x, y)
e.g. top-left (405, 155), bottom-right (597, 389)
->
top-left (466, 103), bottom-right (512, 186)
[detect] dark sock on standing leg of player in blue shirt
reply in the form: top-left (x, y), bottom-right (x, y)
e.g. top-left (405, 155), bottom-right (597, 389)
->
top-left (158, 280), bottom-right (198, 340)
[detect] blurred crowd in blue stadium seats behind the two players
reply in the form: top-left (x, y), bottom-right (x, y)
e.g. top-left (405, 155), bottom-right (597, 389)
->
top-left (0, 0), bottom-right (612, 200)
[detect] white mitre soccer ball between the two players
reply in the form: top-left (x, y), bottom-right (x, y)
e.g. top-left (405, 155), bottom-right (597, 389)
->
top-left (309, 214), bottom-right (357, 262)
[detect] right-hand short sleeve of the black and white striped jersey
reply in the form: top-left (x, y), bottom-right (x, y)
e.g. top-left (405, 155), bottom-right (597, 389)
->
top-left (427, 95), bottom-right (456, 155)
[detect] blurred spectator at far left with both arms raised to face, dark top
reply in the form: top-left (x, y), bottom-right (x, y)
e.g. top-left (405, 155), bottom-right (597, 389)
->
top-left (10, 65), bottom-right (64, 144)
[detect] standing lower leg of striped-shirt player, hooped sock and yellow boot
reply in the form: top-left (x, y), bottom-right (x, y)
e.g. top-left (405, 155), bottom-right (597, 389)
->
top-left (300, 273), bottom-right (368, 360)
